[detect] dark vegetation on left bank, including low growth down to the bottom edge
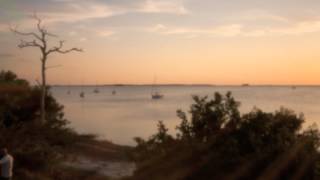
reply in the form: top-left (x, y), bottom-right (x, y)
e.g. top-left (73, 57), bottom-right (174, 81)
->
top-left (0, 71), bottom-right (112, 180)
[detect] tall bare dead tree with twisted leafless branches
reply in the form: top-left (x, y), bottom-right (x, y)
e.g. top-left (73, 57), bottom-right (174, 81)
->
top-left (10, 14), bottom-right (82, 122)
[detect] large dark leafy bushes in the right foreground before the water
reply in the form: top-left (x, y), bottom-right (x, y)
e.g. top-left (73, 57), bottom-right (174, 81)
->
top-left (131, 92), bottom-right (320, 180)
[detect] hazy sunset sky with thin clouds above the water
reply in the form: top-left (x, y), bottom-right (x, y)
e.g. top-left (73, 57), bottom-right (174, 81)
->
top-left (0, 0), bottom-right (320, 85)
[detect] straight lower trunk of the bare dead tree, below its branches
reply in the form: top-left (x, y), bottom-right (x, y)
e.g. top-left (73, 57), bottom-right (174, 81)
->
top-left (40, 57), bottom-right (47, 123)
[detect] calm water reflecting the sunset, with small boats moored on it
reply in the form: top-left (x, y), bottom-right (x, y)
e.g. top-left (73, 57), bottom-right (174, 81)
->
top-left (52, 86), bottom-right (320, 145)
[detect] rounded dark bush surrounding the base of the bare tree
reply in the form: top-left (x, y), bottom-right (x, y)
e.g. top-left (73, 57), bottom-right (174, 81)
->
top-left (0, 71), bottom-right (77, 171)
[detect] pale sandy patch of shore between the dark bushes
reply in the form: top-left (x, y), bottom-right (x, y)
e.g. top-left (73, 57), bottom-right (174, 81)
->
top-left (62, 139), bottom-right (136, 179)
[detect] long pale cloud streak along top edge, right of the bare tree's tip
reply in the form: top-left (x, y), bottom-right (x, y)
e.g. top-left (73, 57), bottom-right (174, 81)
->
top-left (41, 0), bottom-right (188, 22)
